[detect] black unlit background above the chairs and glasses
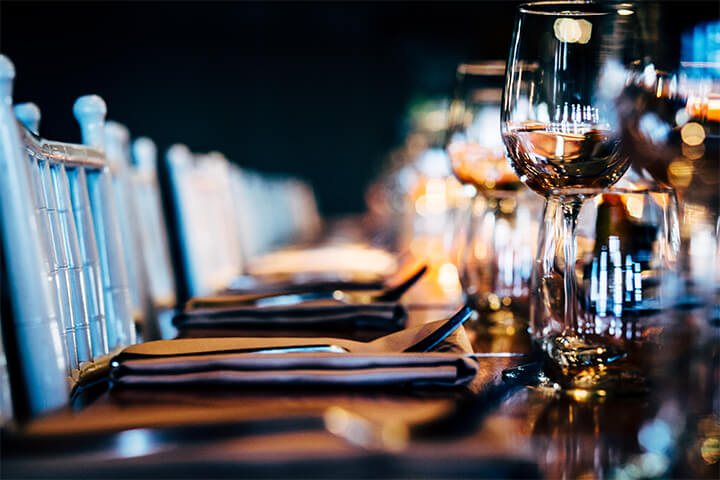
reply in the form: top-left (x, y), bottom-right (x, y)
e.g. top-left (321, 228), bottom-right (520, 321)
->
top-left (0, 1), bottom-right (720, 215)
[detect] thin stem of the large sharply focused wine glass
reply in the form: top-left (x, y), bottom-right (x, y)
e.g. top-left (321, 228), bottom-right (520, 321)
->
top-left (562, 196), bottom-right (582, 336)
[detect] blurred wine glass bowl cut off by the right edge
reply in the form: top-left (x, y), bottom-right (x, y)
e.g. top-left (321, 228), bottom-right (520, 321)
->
top-left (616, 64), bottom-right (720, 193)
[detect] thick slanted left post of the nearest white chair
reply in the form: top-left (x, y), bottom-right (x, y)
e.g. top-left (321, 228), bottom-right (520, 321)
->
top-left (0, 55), bottom-right (68, 415)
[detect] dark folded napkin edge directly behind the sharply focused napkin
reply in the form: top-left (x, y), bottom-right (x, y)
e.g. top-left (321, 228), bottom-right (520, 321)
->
top-left (173, 300), bottom-right (407, 336)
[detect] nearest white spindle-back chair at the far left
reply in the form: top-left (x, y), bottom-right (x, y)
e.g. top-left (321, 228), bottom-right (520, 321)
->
top-left (0, 56), bottom-right (135, 415)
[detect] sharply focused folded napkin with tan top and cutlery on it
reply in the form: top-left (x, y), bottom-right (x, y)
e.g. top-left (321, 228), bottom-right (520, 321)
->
top-left (111, 320), bottom-right (477, 386)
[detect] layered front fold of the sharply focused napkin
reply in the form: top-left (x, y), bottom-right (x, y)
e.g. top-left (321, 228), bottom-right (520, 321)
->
top-left (111, 353), bottom-right (477, 387)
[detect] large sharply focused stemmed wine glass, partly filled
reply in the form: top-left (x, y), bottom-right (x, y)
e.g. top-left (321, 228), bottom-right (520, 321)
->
top-left (501, 2), bottom-right (639, 372)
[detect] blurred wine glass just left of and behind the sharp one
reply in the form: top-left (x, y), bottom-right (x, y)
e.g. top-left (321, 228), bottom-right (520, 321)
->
top-left (446, 60), bottom-right (541, 334)
